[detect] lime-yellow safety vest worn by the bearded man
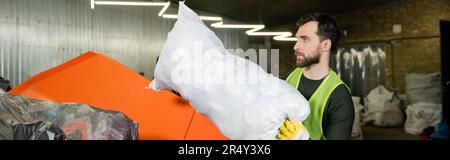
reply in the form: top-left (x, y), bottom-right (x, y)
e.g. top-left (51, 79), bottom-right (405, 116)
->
top-left (286, 68), bottom-right (350, 140)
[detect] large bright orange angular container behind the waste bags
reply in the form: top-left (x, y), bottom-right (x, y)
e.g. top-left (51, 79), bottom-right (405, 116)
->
top-left (9, 52), bottom-right (227, 140)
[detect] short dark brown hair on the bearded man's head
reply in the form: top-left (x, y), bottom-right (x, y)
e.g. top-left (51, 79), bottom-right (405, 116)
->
top-left (297, 13), bottom-right (341, 52)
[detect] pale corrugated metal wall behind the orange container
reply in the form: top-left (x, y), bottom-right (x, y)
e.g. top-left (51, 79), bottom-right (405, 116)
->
top-left (0, 0), bottom-right (248, 86)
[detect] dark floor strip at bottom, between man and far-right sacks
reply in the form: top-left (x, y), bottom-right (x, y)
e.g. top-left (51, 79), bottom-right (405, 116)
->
top-left (361, 126), bottom-right (420, 140)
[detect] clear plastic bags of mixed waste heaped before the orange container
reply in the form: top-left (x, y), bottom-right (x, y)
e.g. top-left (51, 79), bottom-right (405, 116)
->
top-left (0, 93), bottom-right (138, 140)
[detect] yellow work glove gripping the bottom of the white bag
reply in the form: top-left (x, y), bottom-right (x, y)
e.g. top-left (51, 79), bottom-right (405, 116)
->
top-left (277, 119), bottom-right (306, 140)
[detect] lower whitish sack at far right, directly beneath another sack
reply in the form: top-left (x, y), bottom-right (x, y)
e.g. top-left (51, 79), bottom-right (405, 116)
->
top-left (405, 102), bottom-right (442, 135)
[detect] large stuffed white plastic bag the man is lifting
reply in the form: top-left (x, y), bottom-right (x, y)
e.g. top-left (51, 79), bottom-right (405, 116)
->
top-left (150, 3), bottom-right (309, 139)
